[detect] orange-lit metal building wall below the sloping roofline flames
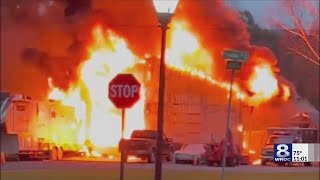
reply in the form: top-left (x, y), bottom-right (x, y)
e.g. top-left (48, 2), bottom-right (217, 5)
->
top-left (145, 62), bottom-right (240, 143)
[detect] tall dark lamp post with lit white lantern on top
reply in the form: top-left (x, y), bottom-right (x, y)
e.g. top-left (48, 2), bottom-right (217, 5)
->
top-left (153, 0), bottom-right (179, 180)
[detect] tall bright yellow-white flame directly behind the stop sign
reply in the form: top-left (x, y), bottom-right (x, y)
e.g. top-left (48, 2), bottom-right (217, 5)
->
top-left (49, 23), bottom-right (144, 151)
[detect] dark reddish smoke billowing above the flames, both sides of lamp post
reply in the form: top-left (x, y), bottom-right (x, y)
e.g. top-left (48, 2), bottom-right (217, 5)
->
top-left (1, 0), bottom-right (284, 98)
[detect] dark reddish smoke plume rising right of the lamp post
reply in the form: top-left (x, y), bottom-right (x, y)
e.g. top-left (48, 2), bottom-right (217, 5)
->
top-left (172, 0), bottom-right (279, 94)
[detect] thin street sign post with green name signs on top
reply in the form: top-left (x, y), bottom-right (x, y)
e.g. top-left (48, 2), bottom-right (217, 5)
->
top-left (221, 50), bottom-right (249, 180)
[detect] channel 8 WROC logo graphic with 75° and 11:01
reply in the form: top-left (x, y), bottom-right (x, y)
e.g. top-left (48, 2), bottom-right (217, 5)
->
top-left (273, 143), bottom-right (320, 162)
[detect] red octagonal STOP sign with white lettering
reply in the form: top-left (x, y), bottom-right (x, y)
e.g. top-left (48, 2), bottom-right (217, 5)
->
top-left (108, 74), bottom-right (141, 108)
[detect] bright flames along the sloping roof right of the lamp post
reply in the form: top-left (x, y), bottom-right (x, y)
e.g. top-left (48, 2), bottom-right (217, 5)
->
top-left (166, 22), bottom-right (290, 105)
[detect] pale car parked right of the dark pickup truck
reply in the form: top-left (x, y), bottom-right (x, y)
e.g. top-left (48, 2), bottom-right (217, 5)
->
top-left (173, 144), bottom-right (208, 165)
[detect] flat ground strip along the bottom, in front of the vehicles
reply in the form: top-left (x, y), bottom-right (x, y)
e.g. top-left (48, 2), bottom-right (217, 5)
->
top-left (1, 160), bottom-right (319, 180)
